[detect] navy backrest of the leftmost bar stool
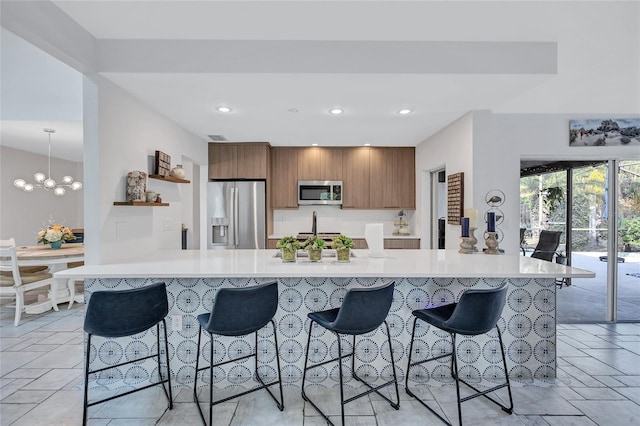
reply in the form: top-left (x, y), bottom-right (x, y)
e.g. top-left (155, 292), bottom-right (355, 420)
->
top-left (84, 282), bottom-right (169, 337)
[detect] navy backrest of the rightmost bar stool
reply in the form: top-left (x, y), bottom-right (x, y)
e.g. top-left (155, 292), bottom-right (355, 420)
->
top-left (443, 285), bottom-right (509, 336)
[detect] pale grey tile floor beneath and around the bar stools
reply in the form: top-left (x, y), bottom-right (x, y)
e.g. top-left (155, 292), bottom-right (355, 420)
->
top-left (0, 305), bottom-right (640, 426)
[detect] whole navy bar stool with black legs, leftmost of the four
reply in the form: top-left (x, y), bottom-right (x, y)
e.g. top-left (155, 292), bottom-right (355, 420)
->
top-left (82, 282), bottom-right (173, 425)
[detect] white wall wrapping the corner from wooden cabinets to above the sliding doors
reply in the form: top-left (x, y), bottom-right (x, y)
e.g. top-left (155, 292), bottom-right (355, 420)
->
top-left (416, 111), bottom-right (640, 253)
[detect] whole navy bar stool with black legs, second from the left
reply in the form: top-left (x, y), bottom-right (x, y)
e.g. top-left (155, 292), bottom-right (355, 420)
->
top-left (193, 281), bottom-right (284, 425)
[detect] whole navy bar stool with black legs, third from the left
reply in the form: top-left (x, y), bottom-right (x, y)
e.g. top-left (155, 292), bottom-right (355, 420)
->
top-left (302, 281), bottom-right (400, 425)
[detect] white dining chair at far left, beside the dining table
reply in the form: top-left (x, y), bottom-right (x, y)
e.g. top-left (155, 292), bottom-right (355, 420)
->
top-left (0, 238), bottom-right (55, 326)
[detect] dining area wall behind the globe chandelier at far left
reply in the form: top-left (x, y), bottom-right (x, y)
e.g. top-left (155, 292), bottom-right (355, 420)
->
top-left (0, 146), bottom-right (84, 245)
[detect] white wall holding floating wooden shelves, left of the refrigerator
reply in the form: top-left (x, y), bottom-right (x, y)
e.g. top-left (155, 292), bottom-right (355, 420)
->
top-left (85, 77), bottom-right (208, 263)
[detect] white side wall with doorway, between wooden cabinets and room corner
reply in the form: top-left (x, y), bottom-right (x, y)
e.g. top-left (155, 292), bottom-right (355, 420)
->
top-left (415, 113), bottom-right (477, 248)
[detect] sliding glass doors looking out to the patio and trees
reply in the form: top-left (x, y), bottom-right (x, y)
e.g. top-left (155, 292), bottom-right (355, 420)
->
top-left (520, 160), bottom-right (640, 323)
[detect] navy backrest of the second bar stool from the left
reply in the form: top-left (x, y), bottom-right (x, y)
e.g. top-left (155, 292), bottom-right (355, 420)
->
top-left (204, 281), bottom-right (278, 336)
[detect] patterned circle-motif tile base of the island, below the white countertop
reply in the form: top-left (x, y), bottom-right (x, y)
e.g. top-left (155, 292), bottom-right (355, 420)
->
top-left (85, 277), bottom-right (556, 389)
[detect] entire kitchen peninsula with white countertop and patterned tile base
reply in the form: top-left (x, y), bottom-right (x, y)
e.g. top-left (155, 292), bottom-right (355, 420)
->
top-left (55, 250), bottom-right (594, 387)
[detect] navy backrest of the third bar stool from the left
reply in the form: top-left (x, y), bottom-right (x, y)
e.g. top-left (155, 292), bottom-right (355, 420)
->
top-left (332, 281), bottom-right (395, 335)
